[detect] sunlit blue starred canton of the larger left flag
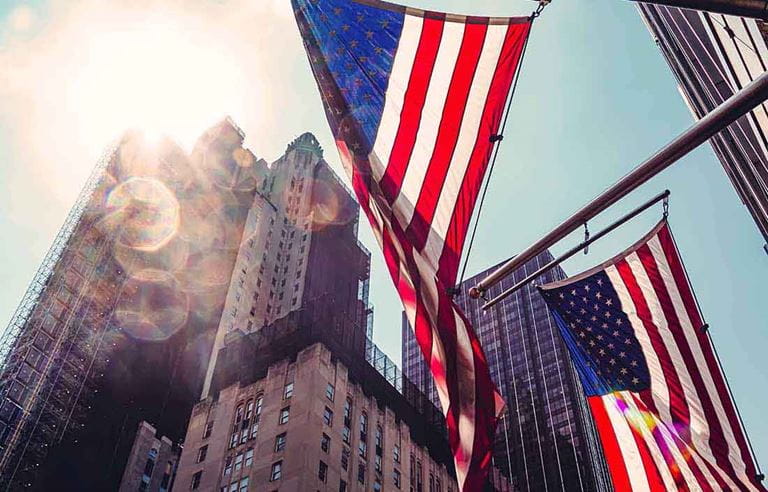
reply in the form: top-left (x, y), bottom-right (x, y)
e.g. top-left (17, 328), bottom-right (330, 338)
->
top-left (293, 0), bottom-right (404, 149)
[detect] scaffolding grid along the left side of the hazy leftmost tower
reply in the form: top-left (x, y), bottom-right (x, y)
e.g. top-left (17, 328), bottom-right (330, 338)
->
top-left (0, 142), bottom-right (119, 490)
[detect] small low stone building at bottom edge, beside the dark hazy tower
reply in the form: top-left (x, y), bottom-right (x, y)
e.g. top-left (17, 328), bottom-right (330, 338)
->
top-left (118, 421), bottom-right (181, 492)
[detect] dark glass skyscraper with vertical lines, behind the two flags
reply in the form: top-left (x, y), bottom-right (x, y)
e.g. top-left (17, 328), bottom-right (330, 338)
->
top-left (402, 252), bottom-right (610, 492)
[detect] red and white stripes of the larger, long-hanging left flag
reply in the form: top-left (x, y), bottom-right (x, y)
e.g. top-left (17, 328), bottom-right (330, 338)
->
top-left (337, 8), bottom-right (530, 490)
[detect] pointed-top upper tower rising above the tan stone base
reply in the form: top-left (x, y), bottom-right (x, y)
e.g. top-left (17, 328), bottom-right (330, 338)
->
top-left (203, 133), bottom-right (373, 397)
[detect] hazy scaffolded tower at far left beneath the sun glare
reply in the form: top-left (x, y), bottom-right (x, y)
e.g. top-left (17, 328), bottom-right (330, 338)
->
top-left (0, 120), bottom-right (265, 491)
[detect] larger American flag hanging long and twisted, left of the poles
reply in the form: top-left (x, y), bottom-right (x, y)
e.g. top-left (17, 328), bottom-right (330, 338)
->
top-left (293, 0), bottom-right (530, 490)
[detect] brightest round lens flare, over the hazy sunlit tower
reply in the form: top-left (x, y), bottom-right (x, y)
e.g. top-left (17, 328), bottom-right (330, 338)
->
top-left (104, 177), bottom-right (180, 251)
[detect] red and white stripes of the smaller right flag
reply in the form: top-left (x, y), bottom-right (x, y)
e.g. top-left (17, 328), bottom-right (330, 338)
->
top-left (589, 222), bottom-right (765, 491)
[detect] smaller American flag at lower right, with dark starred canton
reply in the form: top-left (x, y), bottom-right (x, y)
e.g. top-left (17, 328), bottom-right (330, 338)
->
top-left (541, 221), bottom-right (765, 491)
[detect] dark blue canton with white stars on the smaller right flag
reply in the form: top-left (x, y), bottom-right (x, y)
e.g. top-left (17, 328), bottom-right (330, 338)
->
top-left (540, 271), bottom-right (651, 396)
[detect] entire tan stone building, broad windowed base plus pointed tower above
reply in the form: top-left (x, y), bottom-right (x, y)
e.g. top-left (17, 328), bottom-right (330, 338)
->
top-left (174, 134), bottom-right (511, 492)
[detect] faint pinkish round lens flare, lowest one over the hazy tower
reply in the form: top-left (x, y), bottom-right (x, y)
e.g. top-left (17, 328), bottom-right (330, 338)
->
top-left (115, 270), bottom-right (189, 341)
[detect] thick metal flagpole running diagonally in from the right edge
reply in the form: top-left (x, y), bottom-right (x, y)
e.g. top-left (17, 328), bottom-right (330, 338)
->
top-left (469, 72), bottom-right (768, 299)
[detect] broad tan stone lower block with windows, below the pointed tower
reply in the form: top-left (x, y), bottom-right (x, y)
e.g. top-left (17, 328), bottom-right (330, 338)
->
top-left (176, 343), bottom-right (458, 492)
